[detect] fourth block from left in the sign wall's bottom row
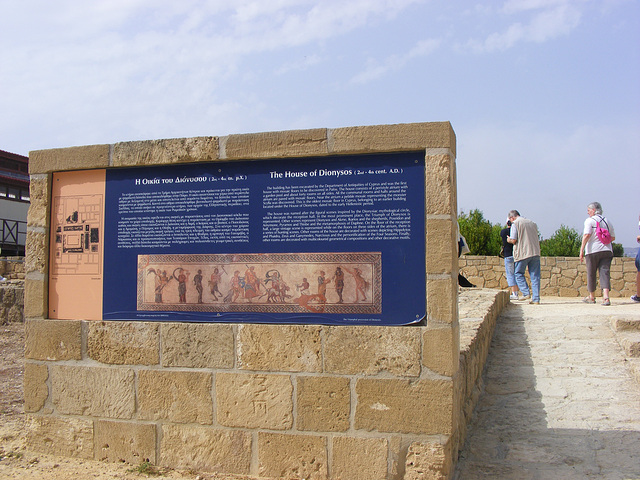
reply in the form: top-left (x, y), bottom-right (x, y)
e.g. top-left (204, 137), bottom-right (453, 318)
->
top-left (258, 432), bottom-right (327, 480)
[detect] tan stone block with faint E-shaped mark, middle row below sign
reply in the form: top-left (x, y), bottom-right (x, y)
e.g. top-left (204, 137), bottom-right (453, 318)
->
top-left (216, 373), bottom-right (293, 430)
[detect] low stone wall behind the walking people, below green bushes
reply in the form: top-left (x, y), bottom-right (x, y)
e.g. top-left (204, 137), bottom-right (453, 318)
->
top-left (458, 255), bottom-right (637, 297)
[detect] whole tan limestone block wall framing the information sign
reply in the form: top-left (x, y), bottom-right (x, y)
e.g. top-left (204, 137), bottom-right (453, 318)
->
top-left (25, 122), bottom-right (465, 479)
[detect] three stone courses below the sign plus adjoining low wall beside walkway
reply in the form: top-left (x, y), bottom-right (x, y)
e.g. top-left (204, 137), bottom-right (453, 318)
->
top-left (24, 290), bottom-right (509, 480)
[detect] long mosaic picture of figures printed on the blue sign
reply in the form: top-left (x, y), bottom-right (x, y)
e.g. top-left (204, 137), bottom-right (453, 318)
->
top-left (137, 252), bottom-right (382, 314)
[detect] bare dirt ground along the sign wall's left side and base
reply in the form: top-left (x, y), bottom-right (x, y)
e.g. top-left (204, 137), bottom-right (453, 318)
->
top-left (0, 323), bottom-right (258, 480)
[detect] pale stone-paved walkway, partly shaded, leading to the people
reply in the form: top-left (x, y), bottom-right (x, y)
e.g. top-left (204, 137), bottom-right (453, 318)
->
top-left (454, 298), bottom-right (640, 480)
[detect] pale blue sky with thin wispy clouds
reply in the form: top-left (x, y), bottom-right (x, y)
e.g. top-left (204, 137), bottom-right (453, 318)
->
top-left (0, 0), bottom-right (640, 247)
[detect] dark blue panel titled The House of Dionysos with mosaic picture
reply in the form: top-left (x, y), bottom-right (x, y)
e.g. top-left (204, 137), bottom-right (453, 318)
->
top-left (103, 152), bottom-right (426, 325)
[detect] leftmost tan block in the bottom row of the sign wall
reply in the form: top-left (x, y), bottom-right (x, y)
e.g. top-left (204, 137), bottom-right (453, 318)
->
top-left (25, 415), bottom-right (93, 459)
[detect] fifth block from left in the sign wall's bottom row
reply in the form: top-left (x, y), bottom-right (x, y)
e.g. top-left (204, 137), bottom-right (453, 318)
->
top-left (331, 437), bottom-right (389, 480)
